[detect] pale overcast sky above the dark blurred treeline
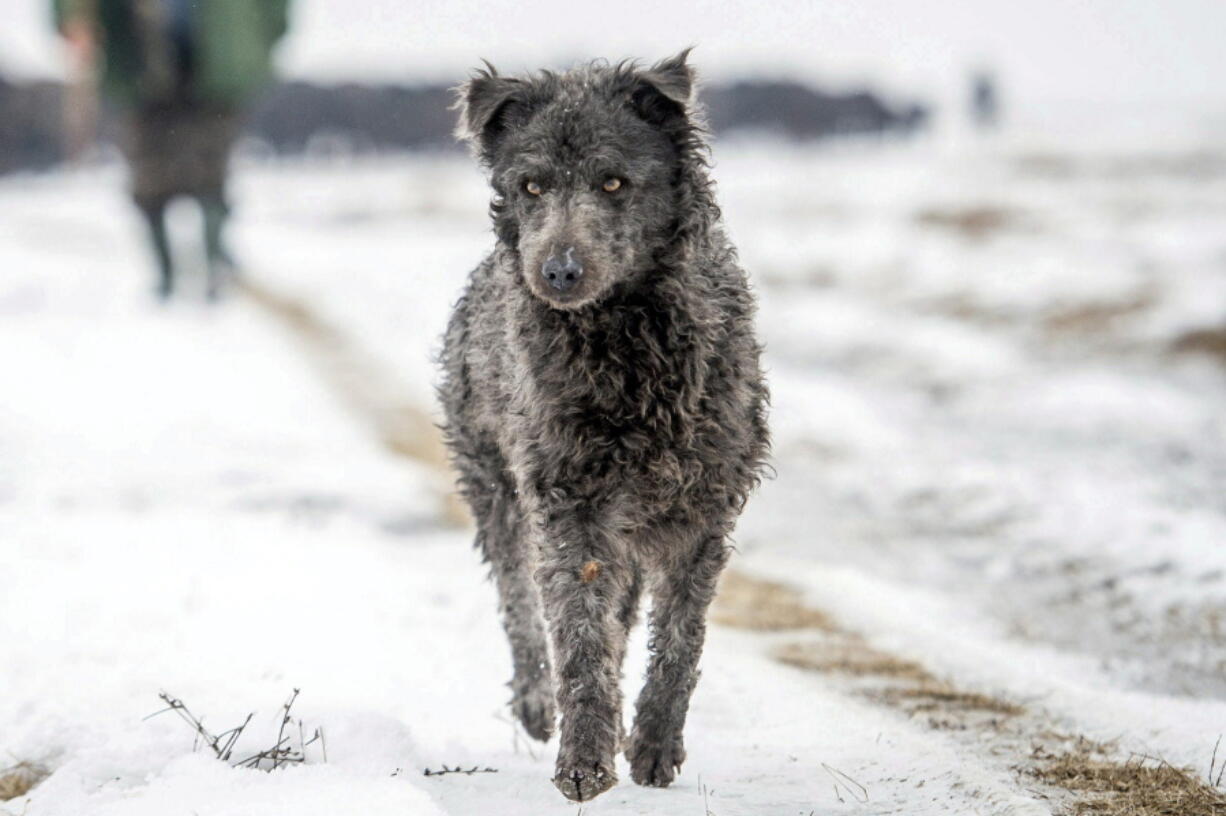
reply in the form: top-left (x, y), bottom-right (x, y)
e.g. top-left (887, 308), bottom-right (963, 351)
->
top-left (0, 0), bottom-right (1226, 118)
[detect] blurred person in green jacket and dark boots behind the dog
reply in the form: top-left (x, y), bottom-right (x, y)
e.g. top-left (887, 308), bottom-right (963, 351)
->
top-left (54, 0), bottom-right (289, 299)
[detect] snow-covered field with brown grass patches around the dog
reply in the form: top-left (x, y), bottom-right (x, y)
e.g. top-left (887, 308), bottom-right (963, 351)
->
top-left (0, 130), bottom-right (1226, 816)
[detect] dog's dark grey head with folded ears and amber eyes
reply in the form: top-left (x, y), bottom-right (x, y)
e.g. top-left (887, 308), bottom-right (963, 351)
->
top-left (457, 51), bottom-right (704, 309)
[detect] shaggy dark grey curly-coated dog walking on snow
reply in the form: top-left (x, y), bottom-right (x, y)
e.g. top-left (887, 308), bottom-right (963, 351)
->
top-left (440, 53), bottom-right (767, 801)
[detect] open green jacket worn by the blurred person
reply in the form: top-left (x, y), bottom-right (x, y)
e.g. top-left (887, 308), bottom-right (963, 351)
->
top-left (53, 0), bottom-right (289, 107)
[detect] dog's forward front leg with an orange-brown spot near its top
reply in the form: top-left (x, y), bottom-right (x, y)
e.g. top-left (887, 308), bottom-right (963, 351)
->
top-left (538, 523), bottom-right (635, 801)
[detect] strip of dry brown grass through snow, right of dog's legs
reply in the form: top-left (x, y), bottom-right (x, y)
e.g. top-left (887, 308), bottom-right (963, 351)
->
top-left (711, 570), bottom-right (1226, 816)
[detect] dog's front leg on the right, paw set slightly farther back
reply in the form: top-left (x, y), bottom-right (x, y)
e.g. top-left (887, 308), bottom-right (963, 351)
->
top-left (625, 535), bottom-right (728, 788)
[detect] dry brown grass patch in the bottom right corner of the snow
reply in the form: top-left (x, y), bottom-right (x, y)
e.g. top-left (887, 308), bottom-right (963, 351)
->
top-left (1031, 744), bottom-right (1226, 816)
